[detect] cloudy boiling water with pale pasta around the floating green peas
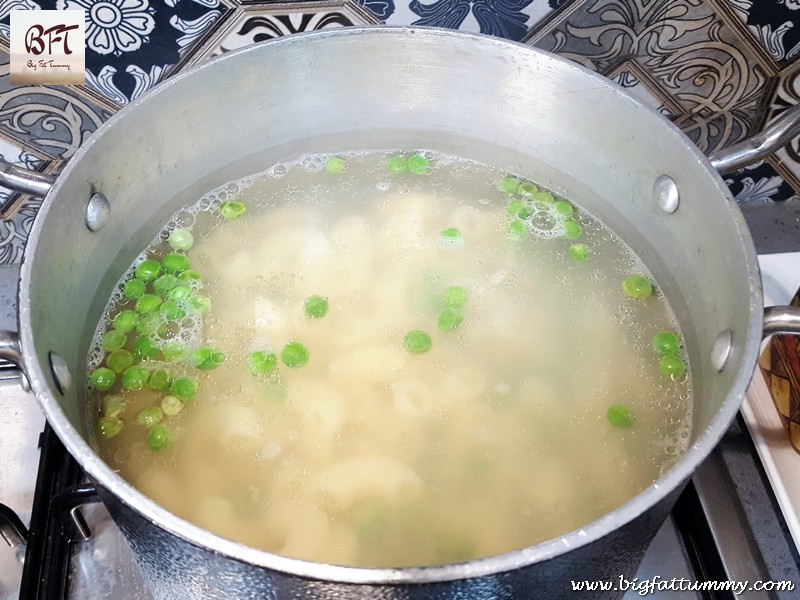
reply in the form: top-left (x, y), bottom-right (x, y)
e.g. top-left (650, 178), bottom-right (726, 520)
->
top-left (89, 153), bottom-right (691, 567)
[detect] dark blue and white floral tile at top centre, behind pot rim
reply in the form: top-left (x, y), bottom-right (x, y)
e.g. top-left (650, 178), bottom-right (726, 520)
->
top-left (386, 0), bottom-right (567, 41)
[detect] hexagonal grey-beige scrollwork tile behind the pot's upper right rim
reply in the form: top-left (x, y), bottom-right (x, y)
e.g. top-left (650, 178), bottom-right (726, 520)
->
top-left (526, 0), bottom-right (769, 152)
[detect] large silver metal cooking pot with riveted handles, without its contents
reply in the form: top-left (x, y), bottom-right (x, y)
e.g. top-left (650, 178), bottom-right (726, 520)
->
top-left (0, 28), bottom-right (800, 599)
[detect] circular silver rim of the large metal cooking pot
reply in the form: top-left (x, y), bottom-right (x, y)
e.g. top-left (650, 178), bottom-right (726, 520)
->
top-left (18, 26), bottom-right (763, 584)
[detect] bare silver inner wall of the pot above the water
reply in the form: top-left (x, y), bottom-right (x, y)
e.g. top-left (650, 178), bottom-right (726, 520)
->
top-left (20, 28), bottom-right (761, 572)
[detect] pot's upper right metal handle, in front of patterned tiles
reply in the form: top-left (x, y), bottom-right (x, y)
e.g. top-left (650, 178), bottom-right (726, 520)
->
top-left (708, 104), bottom-right (800, 173)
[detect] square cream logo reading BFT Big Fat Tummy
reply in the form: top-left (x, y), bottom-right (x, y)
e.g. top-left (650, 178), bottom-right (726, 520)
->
top-left (10, 10), bottom-right (86, 85)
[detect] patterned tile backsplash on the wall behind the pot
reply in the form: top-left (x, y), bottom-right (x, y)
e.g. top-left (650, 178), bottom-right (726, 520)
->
top-left (0, 0), bottom-right (800, 264)
